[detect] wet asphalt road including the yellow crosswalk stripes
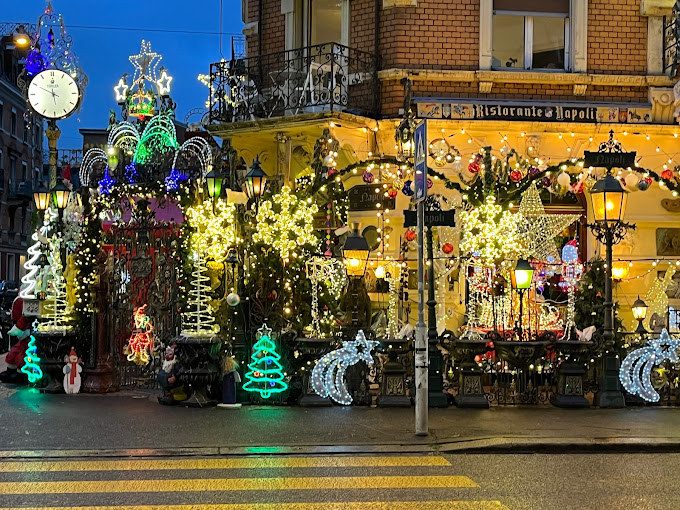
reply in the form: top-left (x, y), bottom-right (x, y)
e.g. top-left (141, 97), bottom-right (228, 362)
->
top-left (0, 454), bottom-right (680, 510)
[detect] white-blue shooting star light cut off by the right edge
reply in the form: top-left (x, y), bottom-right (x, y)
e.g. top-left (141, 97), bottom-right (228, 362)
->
top-left (619, 328), bottom-right (680, 402)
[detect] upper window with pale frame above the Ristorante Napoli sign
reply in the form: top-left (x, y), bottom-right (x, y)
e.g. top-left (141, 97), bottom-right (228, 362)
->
top-left (491, 0), bottom-right (569, 71)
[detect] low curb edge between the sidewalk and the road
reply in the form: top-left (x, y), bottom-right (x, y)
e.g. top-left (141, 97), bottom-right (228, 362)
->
top-left (0, 437), bottom-right (680, 460)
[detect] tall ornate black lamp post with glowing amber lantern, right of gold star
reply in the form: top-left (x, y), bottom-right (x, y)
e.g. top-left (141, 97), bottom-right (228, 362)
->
top-left (588, 165), bottom-right (635, 407)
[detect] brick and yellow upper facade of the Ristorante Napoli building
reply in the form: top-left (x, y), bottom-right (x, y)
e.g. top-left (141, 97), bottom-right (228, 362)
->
top-left (216, 0), bottom-right (680, 330)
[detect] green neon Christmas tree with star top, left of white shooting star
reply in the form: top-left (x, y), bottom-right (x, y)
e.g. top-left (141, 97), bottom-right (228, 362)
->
top-left (243, 324), bottom-right (288, 398)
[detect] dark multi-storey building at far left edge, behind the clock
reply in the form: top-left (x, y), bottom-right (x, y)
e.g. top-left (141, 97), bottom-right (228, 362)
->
top-left (0, 35), bottom-right (43, 281)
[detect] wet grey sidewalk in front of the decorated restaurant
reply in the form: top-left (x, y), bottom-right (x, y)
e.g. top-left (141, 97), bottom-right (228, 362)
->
top-left (0, 385), bottom-right (680, 457)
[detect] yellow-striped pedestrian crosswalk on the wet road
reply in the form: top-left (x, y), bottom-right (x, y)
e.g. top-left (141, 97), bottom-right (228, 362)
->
top-left (0, 455), bottom-right (507, 510)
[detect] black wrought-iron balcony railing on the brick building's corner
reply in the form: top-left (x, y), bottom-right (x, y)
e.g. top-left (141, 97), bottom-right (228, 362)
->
top-left (209, 43), bottom-right (379, 123)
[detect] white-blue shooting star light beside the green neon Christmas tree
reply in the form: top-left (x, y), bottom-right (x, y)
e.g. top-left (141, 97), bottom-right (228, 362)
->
top-left (312, 330), bottom-right (380, 406)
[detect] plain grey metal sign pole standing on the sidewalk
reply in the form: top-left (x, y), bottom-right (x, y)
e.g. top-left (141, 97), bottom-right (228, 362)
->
top-left (415, 200), bottom-right (428, 436)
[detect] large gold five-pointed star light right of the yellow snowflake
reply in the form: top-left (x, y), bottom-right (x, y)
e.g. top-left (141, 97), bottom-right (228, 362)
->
top-left (517, 182), bottom-right (581, 263)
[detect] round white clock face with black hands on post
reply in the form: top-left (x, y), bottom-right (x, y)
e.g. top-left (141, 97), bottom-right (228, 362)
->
top-left (28, 69), bottom-right (80, 119)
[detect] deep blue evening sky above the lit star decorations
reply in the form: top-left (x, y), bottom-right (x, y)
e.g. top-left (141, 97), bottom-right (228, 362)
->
top-left (0, 0), bottom-right (243, 149)
